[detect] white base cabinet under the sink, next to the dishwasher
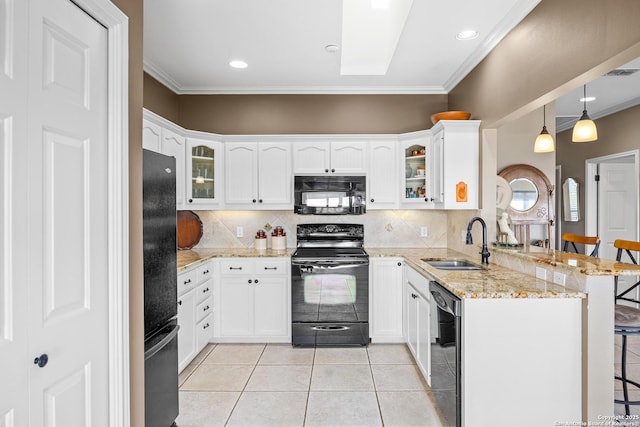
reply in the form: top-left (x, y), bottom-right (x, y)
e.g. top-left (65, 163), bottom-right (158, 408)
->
top-left (404, 266), bottom-right (431, 384)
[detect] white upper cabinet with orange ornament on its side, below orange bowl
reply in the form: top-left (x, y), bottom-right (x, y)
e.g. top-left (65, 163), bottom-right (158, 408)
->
top-left (430, 120), bottom-right (480, 209)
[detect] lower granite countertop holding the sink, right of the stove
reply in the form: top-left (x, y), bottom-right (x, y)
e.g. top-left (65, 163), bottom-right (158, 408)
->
top-left (367, 248), bottom-right (585, 298)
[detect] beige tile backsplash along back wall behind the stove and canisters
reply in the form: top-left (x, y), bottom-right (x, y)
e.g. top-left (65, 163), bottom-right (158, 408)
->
top-left (188, 210), bottom-right (451, 248)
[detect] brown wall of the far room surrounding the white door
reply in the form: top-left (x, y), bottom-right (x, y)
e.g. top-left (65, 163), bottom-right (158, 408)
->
top-left (556, 105), bottom-right (640, 240)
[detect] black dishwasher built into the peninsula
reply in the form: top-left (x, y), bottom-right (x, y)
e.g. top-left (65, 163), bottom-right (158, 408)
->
top-left (429, 281), bottom-right (462, 427)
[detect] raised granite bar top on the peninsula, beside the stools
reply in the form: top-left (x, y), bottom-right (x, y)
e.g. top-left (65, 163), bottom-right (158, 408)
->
top-left (489, 246), bottom-right (640, 276)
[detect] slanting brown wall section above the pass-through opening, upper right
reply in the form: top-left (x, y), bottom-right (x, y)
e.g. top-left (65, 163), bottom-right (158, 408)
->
top-left (449, 0), bottom-right (640, 128)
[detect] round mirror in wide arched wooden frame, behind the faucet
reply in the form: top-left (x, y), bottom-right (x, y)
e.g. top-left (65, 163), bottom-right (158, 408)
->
top-left (498, 164), bottom-right (554, 247)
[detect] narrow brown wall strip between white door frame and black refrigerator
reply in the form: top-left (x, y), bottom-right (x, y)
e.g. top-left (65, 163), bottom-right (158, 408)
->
top-left (112, 0), bottom-right (144, 427)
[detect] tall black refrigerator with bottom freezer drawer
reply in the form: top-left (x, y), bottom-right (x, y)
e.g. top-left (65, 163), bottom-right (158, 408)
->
top-left (142, 150), bottom-right (179, 427)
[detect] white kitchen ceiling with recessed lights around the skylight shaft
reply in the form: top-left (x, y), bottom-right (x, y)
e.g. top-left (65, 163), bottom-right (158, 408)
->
top-left (144, 0), bottom-right (540, 94)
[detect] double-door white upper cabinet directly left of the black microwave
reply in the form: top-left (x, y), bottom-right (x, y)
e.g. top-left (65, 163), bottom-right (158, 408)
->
top-left (224, 142), bottom-right (293, 209)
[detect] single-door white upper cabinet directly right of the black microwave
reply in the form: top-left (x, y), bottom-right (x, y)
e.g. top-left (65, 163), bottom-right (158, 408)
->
top-left (367, 140), bottom-right (399, 209)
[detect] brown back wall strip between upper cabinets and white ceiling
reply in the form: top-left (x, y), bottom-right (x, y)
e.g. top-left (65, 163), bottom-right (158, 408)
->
top-left (178, 95), bottom-right (447, 135)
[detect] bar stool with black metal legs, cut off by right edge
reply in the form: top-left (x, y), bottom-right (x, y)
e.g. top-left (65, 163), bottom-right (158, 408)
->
top-left (613, 240), bottom-right (640, 415)
